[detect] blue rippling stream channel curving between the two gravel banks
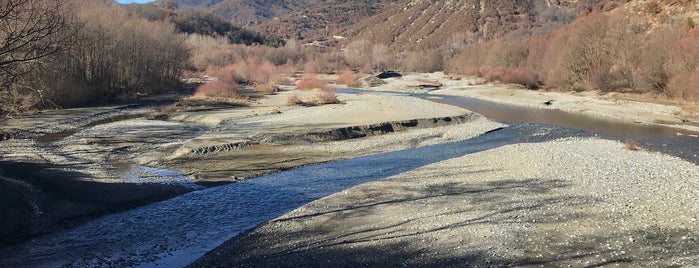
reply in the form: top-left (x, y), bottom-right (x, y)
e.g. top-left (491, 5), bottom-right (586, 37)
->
top-left (0, 90), bottom-right (699, 267)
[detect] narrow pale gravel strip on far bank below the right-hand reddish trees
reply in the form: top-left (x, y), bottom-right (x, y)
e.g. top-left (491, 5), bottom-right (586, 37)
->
top-left (360, 72), bottom-right (699, 132)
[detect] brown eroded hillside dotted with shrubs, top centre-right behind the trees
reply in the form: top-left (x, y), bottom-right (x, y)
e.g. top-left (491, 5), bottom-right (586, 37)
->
top-left (342, 0), bottom-right (628, 49)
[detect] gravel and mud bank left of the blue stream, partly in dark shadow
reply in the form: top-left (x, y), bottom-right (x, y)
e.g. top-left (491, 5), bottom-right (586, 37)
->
top-left (0, 91), bottom-right (502, 248)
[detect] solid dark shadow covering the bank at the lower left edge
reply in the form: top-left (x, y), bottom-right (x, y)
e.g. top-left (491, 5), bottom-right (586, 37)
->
top-left (0, 161), bottom-right (192, 247)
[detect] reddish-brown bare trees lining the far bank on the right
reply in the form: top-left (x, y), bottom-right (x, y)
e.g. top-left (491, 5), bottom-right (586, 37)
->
top-left (451, 7), bottom-right (699, 101)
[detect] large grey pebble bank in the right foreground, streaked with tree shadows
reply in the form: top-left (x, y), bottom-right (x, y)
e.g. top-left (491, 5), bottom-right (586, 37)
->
top-left (192, 138), bottom-right (699, 267)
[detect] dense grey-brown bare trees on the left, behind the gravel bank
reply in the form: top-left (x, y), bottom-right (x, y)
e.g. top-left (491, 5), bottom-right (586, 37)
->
top-left (0, 0), bottom-right (283, 115)
